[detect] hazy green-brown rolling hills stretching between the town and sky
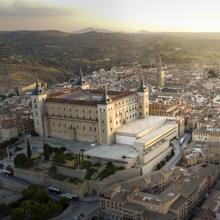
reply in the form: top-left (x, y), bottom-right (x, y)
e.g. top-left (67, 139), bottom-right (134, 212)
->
top-left (0, 30), bottom-right (220, 91)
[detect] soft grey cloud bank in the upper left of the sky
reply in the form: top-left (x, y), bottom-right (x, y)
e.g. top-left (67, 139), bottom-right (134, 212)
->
top-left (0, 0), bottom-right (77, 17)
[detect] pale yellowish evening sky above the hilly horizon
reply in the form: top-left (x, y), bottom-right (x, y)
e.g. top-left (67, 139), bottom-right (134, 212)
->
top-left (0, 0), bottom-right (220, 32)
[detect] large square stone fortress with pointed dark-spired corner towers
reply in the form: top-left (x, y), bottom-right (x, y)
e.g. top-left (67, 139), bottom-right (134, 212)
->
top-left (32, 75), bottom-right (149, 145)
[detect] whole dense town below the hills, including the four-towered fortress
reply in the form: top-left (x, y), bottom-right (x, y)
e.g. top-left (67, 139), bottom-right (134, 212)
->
top-left (0, 49), bottom-right (220, 220)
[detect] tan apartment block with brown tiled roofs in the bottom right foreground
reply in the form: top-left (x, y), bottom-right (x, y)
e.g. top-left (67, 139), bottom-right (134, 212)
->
top-left (100, 165), bottom-right (219, 220)
